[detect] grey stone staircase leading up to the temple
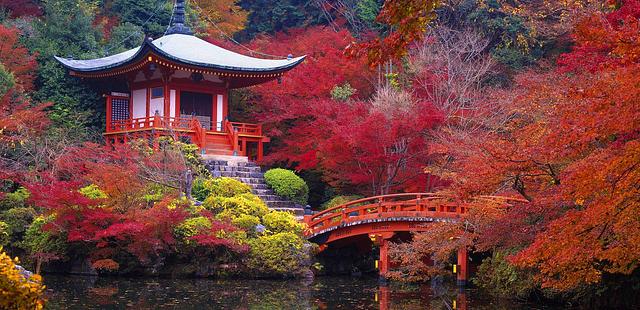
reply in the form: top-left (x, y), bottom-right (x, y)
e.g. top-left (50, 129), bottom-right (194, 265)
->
top-left (204, 156), bottom-right (304, 216)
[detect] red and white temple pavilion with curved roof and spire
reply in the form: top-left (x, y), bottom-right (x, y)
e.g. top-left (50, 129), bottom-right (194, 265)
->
top-left (56, 0), bottom-right (304, 160)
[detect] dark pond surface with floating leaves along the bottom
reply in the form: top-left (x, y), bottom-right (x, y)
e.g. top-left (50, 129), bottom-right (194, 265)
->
top-left (44, 275), bottom-right (545, 309)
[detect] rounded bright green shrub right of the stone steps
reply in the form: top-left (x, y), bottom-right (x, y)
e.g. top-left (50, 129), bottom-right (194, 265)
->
top-left (264, 168), bottom-right (309, 205)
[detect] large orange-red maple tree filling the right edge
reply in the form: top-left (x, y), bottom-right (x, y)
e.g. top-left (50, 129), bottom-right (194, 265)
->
top-left (460, 1), bottom-right (640, 291)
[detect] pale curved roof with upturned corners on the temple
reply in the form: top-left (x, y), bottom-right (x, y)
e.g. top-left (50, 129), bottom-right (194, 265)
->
top-left (55, 33), bottom-right (306, 73)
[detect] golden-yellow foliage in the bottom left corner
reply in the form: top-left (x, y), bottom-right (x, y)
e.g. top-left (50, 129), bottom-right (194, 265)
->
top-left (0, 248), bottom-right (45, 309)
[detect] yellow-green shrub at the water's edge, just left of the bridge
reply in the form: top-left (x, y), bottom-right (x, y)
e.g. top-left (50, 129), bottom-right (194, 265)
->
top-left (246, 232), bottom-right (311, 276)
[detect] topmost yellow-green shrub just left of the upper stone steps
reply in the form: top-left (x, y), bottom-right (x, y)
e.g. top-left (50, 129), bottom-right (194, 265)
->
top-left (191, 177), bottom-right (251, 201)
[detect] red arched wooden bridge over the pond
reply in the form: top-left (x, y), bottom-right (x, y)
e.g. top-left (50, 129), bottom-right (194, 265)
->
top-left (304, 193), bottom-right (523, 283)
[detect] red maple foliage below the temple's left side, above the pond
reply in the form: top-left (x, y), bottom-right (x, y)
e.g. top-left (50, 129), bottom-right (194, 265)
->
top-left (25, 143), bottom-right (195, 263)
